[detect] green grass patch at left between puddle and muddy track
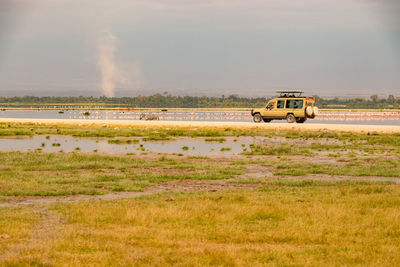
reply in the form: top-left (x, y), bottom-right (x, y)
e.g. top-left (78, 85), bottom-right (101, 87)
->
top-left (0, 152), bottom-right (243, 196)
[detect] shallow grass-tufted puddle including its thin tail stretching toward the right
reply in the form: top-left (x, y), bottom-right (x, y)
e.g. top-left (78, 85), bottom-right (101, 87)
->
top-left (0, 135), bottom-right (344, 157)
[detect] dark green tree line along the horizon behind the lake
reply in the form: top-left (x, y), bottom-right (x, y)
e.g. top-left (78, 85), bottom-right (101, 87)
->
top-left (0, 94), bottom-right (400, 109)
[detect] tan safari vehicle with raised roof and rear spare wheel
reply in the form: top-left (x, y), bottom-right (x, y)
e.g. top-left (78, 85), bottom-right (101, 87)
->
top-left (251, 91), bottom-right (318, 123)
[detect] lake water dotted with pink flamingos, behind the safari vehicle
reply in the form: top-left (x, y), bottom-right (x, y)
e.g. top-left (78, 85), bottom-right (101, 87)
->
top-left (0, 110), bottom-right (400, 126)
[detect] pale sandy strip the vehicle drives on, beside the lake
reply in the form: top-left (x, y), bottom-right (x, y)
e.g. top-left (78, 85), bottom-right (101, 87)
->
top-left (0, 118), bottom-right (400, 133)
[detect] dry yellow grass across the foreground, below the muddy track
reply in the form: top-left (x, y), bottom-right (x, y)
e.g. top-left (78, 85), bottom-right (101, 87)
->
top-left (4, 185), bottom-right (400, 266)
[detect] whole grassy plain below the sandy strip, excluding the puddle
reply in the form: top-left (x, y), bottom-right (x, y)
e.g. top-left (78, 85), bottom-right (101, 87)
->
top-left (0, 124), bottom-right (400, 266)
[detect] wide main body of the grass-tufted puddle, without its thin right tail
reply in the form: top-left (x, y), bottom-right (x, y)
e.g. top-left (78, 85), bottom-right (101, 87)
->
top-left (0, 135), bottom-right (257, 156)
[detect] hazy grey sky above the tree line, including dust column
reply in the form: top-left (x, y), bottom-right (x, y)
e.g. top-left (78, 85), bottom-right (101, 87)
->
top-left (0, 0), bottom-right (400, 97)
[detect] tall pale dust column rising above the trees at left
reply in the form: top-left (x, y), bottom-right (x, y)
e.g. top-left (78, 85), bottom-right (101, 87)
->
top-left (97, 30), bottom-right (116, 97)
